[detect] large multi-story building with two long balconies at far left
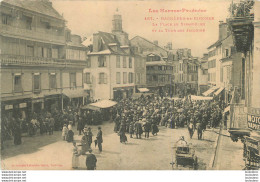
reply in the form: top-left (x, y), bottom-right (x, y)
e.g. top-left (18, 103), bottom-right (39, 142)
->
top-left (0, 0), bottom-right (85, 117)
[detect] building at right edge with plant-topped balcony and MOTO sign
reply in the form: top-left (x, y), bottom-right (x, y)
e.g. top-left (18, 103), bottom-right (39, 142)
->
top-left (227, 1), bottom-right (260, 170)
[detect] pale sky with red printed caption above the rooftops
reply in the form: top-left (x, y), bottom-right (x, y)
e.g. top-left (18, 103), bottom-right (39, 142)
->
top-left (52, 0), bottom-right (231, 57)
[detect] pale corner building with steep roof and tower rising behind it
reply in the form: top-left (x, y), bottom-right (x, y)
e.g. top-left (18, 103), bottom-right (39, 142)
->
top-left (84, 10), bottom-right (135, 100)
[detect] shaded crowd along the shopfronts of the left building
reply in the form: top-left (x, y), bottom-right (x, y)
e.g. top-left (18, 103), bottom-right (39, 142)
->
top-left (1, 103), bottom-right (107, 149)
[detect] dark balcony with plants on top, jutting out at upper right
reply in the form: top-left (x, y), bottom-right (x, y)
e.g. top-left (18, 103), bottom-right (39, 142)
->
top-left (227, 1), bottom-right (254, 53)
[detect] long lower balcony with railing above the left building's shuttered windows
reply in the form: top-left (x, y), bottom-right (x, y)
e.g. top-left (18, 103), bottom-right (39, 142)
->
top-left (0, 54), bottom-right (86, 69)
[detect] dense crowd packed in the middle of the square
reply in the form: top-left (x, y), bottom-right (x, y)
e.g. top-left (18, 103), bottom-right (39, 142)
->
top-left (112, 95), bottom-right (224, 143)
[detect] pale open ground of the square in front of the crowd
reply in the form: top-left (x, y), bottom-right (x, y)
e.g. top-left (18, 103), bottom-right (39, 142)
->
top-left (2, 123), bottom-right (224, 170)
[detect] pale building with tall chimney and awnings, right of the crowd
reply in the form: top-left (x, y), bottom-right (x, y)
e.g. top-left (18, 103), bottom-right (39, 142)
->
top-left (204, 21), bottom-right (243, 99)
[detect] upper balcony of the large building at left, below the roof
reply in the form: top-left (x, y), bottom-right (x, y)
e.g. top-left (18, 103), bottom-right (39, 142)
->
top-left (0, 24), bottom-right (65, 45)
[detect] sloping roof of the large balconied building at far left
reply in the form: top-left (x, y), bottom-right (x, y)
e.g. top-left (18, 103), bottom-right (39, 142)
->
top-left (2, 0), bottom-right (64, 20)
